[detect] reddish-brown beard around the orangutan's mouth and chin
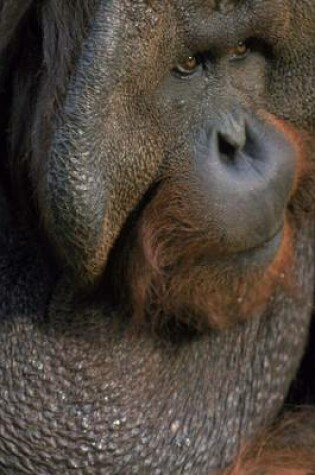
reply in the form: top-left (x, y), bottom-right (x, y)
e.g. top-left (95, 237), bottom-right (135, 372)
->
top-left (124, 182), bottom-right (293, 327)
